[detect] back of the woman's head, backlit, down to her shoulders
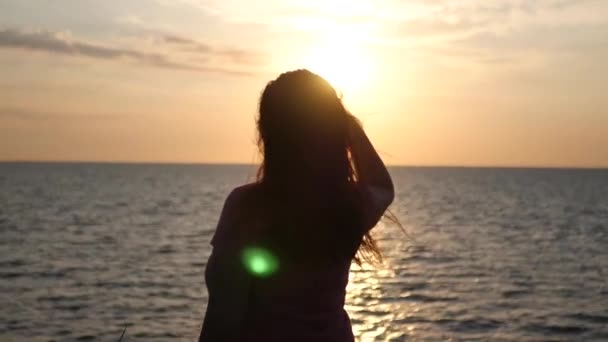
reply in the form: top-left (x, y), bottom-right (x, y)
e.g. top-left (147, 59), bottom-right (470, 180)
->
top-left (258, 70), bottom-right (351, 186)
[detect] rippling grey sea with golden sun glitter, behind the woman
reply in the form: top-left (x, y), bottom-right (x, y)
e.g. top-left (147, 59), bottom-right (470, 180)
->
top-left (0, 163), bottom-right (608, 342)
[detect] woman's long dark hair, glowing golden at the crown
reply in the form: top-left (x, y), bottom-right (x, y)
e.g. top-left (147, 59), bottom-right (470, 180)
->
top-left (257, 70), bottom-right (382, 264)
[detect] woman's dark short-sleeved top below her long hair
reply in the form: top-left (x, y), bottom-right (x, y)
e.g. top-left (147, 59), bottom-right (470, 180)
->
top-left (201, 184), bottom-right (364, 342)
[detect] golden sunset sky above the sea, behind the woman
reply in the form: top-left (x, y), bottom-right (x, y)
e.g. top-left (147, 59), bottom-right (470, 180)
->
top-left (0, 0), bottom-right (608, 167)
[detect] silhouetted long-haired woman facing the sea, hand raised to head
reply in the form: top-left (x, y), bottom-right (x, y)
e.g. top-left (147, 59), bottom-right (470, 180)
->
top-left (199, 70), bottom-right (394, 342)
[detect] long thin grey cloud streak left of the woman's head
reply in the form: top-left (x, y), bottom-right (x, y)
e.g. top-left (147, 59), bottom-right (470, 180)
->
top-left (0, 29), bottom-right (254, 75)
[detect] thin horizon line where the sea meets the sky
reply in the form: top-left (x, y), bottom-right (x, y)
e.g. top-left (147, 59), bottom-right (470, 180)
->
top-left (0, 159), bottom-right (608, 170)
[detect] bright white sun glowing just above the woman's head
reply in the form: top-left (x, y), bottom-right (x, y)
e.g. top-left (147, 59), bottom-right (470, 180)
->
top-left (304, 41), bottom-right (373, 97)
